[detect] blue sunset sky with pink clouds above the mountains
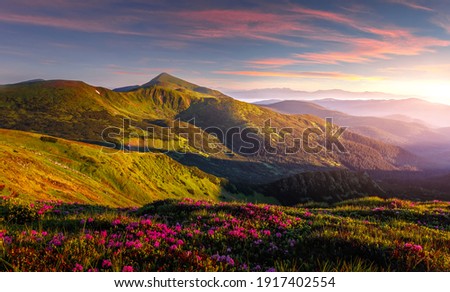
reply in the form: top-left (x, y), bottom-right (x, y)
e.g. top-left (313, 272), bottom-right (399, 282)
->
top-left (0, 0), bottom-right (450, 103)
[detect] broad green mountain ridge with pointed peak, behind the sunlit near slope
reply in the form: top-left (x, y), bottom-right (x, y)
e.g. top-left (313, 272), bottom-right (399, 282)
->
top-left (0, 74), bottom-right (430, 197)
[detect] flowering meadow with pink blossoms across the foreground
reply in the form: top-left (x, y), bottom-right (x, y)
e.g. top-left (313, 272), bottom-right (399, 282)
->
top-left (0, 197), bottom-right (450, 272)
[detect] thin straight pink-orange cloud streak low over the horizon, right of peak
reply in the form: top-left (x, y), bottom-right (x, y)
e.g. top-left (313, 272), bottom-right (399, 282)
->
top-left (213, 71), bottom-right (381, 81)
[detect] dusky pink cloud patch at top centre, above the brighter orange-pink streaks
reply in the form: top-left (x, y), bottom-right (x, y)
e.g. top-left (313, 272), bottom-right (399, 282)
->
top-left (167, 6), bottom-right (370, 47)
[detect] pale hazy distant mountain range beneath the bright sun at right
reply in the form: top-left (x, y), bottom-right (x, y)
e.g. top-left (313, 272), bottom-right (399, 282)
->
top-left (229, 88), bottom-right (450, 128)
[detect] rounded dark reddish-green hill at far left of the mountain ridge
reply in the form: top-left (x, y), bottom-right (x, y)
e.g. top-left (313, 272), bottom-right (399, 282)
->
top-left (0, 80), bottom-right (121, 139)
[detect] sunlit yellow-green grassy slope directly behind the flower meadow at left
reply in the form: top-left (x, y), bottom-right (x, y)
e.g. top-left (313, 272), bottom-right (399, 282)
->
top-left (0, 129), bottom-right (230, 206)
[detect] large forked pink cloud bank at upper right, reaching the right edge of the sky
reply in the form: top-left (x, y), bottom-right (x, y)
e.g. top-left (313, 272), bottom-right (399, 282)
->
top-left (166, 6), bottom-right (450, 68)
